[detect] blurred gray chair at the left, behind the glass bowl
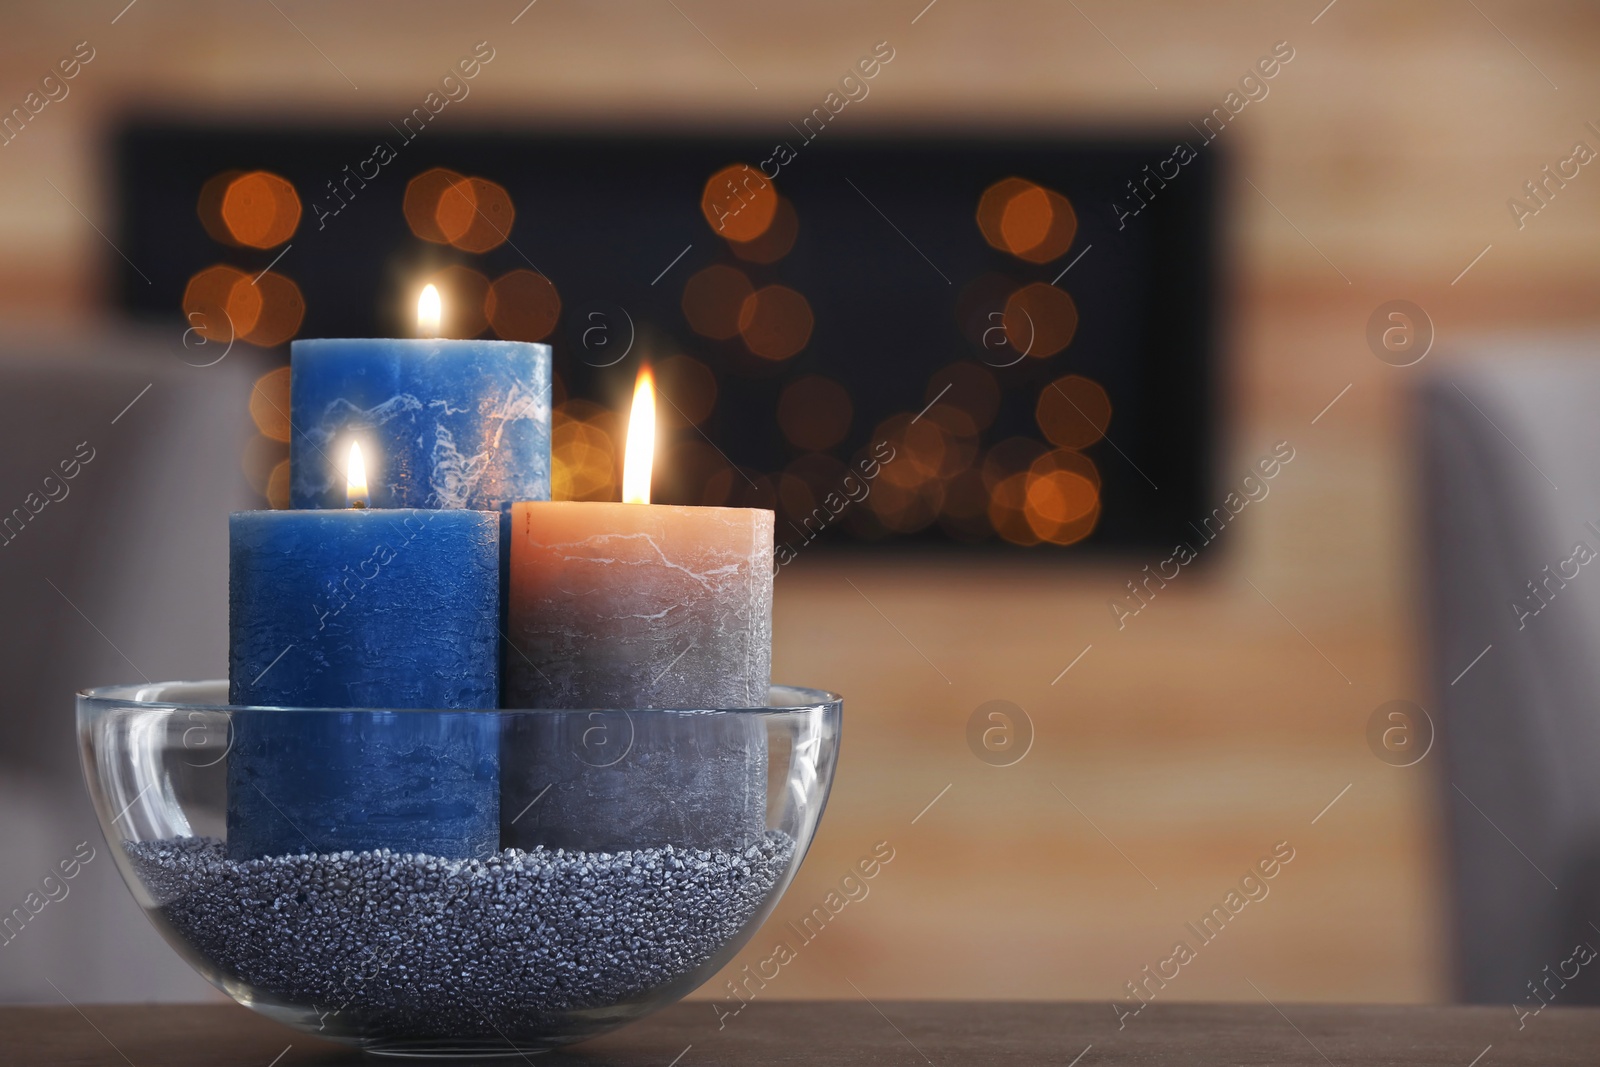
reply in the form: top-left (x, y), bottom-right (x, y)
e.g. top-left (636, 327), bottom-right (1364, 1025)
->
top-left (0, 326), bottom-right (267, 1005)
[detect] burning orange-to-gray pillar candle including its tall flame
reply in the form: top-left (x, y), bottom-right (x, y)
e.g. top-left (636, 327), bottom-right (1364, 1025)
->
top-left (501, 370), bottom-right (773, 851)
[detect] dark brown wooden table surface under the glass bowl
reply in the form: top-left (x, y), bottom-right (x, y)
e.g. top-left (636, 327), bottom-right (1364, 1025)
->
top-left (0, 1000), bottom-right (1600, 1067)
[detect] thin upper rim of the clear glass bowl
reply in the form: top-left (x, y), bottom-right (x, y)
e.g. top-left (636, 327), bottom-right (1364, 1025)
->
top-left (77, 678), bottom-right (845, 715)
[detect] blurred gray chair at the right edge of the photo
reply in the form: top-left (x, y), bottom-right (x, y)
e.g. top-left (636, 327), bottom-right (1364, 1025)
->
top-left (1418, 347), bottom-right (1600, 1008)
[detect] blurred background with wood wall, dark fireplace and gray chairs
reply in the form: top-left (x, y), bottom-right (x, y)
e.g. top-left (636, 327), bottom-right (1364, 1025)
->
top-left (0, 0), bottom-right (1600, 1003)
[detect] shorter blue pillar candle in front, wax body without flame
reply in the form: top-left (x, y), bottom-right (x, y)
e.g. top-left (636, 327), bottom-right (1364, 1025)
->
top-left (227, 509), bottom-right (499, 861)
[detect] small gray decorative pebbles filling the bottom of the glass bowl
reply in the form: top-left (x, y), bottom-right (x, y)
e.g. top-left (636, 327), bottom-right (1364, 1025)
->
top-left (125, 832), bottom-right (794, 1037)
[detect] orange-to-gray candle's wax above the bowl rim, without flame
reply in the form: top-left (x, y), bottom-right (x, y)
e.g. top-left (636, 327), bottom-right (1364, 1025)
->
top-left (506, 501), bottom-right (773, 709)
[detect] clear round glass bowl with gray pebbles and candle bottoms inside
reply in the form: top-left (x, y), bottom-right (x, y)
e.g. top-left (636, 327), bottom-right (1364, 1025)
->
top-left (77, 681), bottom-right (843, 1056)
